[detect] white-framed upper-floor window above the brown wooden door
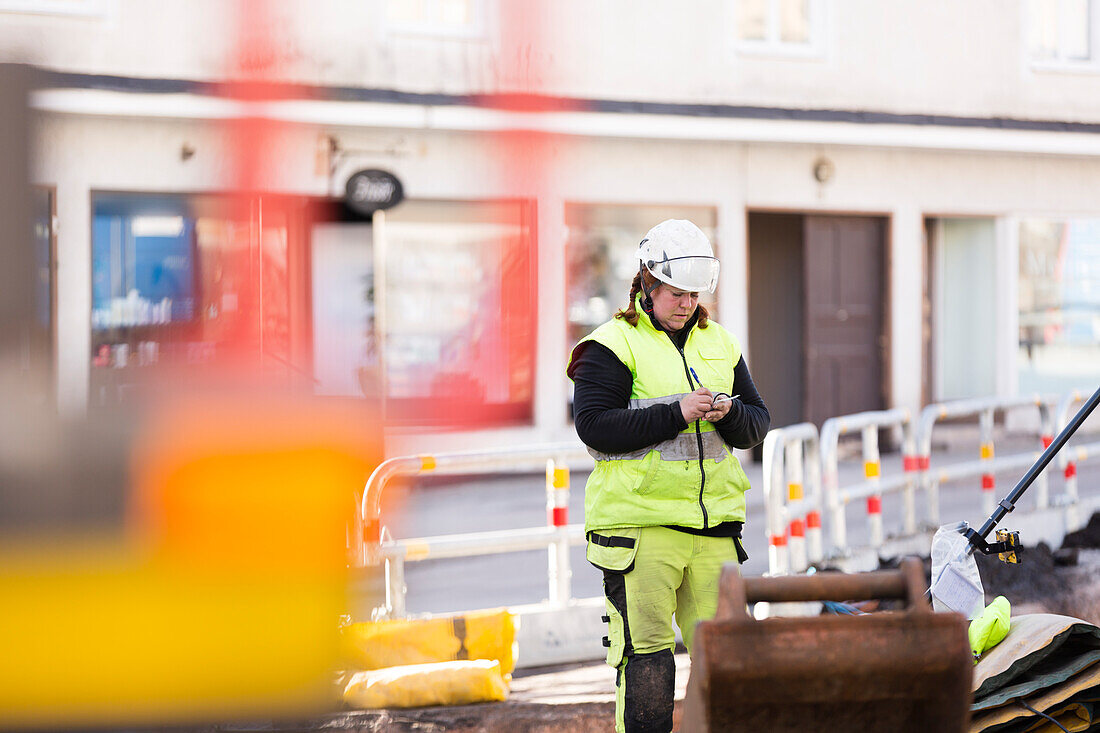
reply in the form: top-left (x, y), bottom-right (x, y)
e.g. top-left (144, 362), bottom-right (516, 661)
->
top-left (735, 0), bottom-right (822, 55)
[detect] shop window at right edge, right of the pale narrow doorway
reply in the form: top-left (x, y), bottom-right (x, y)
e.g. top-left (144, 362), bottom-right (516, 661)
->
top-left (1018, 219), bottom-right (1100, 393)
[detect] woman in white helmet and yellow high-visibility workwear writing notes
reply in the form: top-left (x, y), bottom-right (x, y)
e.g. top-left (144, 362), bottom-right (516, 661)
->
top-left (567, 219), bottom-right (771, 733)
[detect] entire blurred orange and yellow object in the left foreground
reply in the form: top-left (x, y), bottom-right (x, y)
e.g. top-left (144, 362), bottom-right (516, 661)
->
top-left (0, 397), bottom-right (381, 729)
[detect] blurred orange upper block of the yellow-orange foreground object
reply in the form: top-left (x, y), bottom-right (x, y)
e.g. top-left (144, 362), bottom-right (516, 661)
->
top-left (131, 395), bottom-right (382, 573)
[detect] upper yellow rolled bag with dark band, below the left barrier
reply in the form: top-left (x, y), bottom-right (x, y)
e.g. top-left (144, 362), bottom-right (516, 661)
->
top-left (341, 609), bottom-right (516, 675)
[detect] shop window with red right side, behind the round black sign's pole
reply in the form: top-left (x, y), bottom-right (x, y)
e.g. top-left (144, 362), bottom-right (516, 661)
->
top-left (311, 200), bottom-right (537, 426)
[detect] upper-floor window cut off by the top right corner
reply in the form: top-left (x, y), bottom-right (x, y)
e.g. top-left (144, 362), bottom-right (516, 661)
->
top-left (1026, 0), bottom-right (1100, 66)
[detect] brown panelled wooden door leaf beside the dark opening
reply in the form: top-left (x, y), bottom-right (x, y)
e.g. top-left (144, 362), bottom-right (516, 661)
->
top-left (803, 217), bottom-right (886, 426)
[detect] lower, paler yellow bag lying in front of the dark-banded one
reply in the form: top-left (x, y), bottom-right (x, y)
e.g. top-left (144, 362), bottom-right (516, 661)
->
top-left (343, 659), bottom-right (508, 709)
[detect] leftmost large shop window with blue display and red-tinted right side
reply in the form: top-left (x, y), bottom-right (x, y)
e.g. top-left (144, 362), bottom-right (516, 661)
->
top-left (91, 194), bottom-right (294, 405)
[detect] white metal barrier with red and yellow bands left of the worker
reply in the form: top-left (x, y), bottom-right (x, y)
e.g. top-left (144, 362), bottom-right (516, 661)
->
top-left (350, 444), bottom-right (589, 617)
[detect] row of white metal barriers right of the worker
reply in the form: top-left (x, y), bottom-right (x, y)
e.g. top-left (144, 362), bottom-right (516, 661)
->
top-left (763, 392), bottom-right (1100, 575)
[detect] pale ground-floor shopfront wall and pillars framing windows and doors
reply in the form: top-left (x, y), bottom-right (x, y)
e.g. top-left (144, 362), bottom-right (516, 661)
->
top-left (35, 107), bottom-right (1100, 455)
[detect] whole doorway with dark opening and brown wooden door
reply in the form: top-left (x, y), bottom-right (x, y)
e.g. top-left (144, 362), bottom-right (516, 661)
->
top-left (748, 212), bottom-right (887, 427)
